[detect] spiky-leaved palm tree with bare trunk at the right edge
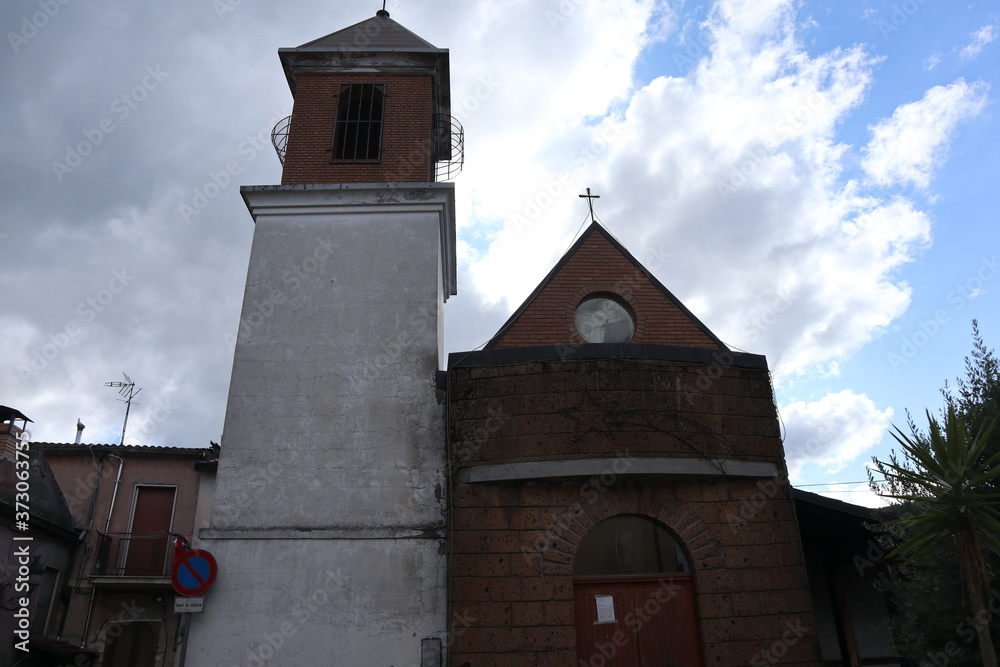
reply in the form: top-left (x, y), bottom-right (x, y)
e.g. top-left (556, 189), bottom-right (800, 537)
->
top-left (869, 406), bottom-right (1000, 667)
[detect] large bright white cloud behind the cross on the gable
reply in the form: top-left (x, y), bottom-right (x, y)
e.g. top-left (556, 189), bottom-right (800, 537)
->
top-left (461, 1), bottom-right (930, 379)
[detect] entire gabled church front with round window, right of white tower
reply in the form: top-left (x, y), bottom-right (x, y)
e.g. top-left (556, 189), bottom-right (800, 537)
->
top-left (447, 226), bottom-right (819, 667)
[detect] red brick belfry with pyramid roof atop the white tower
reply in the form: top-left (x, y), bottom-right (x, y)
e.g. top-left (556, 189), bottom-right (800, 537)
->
top-left (274, 10), bottom-right (463, 185)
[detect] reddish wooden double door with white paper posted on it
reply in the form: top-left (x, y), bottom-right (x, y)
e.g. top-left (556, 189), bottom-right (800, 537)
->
top-left (573, 574), bottom-right (702, 667)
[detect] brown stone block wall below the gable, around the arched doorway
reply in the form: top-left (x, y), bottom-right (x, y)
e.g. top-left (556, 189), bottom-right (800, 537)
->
top-left (449, 359), bottom-right (819, 667)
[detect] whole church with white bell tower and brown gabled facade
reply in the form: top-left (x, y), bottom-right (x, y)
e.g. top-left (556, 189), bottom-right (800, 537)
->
top-left (187, 10), bottom-right (821, 667)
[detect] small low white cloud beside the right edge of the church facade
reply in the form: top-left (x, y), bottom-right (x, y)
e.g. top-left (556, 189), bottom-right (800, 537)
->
top-left (780, 389), bottom-right (893, 484)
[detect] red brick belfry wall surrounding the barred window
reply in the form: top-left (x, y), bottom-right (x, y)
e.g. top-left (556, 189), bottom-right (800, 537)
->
top-left (281, 72), bottom-right (434, 185)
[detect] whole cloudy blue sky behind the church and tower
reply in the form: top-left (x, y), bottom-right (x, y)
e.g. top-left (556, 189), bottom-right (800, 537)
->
top-left (0, 0), bottom-right (1000, 505)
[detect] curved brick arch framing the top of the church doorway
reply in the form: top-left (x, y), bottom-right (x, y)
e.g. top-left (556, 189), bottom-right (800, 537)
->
top-left (541, 483), bottom-right (725, 576)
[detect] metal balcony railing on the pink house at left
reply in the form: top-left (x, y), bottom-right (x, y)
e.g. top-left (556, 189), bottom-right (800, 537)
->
top-left (93, 531), bottom-right (176, 577)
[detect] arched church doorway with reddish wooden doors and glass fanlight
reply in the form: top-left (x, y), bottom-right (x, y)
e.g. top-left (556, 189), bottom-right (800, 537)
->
top-left (573, 515), bottom-right (702, 667)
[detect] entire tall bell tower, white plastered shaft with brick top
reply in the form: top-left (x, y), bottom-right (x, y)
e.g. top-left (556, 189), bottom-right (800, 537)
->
top-left (187, 10), bottom-right (461, 667)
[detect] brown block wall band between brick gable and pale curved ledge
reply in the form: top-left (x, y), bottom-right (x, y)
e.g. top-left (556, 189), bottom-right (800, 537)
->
top-left (449, 353), bottom-right (784, 468)
